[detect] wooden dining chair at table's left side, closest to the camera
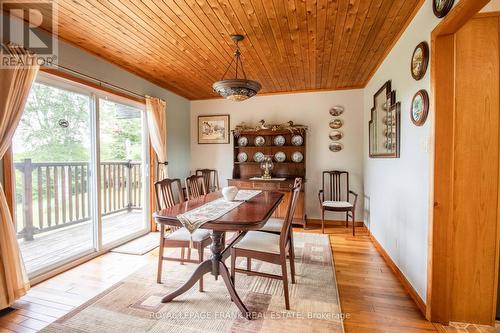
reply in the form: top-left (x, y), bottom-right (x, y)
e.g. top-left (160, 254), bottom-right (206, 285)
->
top-left (154, 178), bottom-right (212, 291)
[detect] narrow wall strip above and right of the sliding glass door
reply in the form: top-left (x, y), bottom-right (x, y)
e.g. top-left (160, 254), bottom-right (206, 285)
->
top-left (1, 13), bottom-right (190, 177)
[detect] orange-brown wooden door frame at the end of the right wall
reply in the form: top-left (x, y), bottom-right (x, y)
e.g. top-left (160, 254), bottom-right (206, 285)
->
top-left (426, 0), bottom-right (498, 324)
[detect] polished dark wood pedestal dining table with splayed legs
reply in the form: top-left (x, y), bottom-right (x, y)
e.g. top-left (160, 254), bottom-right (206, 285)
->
top-left (153, 191), bottom-right (284, 319)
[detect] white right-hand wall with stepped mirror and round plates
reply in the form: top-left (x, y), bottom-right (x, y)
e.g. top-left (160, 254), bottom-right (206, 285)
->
top-left (363, 0), bottom-right (500, 301)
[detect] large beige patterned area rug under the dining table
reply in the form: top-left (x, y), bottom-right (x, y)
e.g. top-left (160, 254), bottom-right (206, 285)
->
top-left (42, 233), bottom-right (343, 333)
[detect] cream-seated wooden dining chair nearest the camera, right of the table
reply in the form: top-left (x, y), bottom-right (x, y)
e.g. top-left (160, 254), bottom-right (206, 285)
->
top-left (231, 180), bottom-right (302, 310)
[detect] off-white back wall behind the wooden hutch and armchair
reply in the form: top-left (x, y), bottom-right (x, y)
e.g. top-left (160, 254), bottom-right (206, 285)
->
top-left (191, 90), bottom-right (365, 221)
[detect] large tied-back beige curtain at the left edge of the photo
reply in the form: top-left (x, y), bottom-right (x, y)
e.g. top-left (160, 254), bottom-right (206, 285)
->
top-left (0, 45), bottom-right (38, 309)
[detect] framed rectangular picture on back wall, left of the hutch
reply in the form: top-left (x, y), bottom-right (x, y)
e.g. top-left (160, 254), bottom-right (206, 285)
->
top-left (198, 114), bottom-right (230, 144)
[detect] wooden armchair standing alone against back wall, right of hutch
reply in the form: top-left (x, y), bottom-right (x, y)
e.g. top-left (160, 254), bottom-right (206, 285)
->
top-left (318, 170), bottom-right (358, 236)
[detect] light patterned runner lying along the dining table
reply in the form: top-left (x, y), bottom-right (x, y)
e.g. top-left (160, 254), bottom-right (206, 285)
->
top-left (177, 190), bottom-right (262, 239)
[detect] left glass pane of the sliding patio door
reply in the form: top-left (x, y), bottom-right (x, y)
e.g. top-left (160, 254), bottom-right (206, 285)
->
top-left (13, 83), bottom-right (94, 276)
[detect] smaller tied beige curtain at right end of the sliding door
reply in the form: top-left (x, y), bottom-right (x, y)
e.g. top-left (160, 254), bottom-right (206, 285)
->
top-left (146, 96), bottom-right (168, 179)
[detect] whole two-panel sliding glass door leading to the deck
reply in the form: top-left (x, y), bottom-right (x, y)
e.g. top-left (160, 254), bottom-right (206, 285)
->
top-left (12, 74), bottom-right (149, 278)
